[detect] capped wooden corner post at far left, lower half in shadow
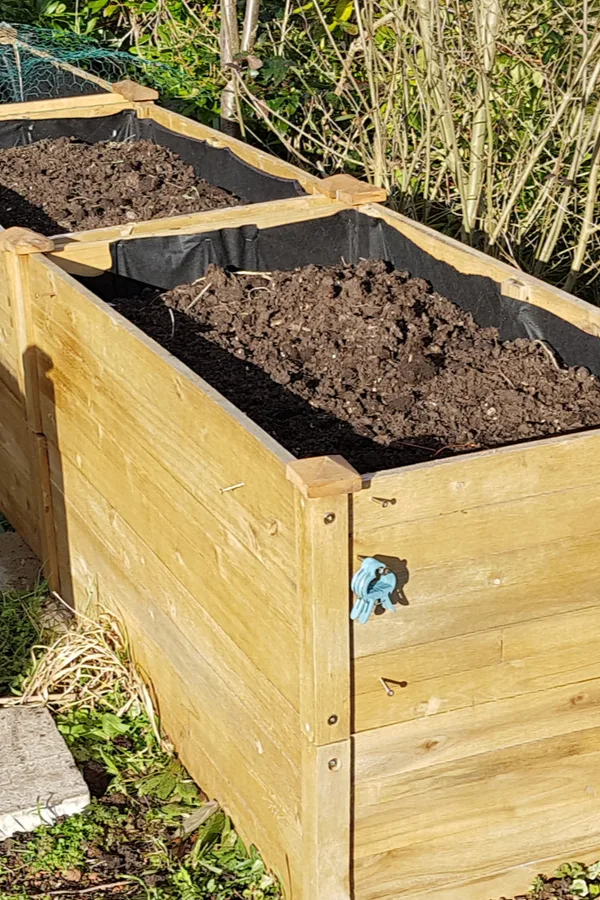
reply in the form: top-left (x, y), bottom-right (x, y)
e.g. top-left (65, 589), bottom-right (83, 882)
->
top-left (0, 227), bottom-right (60, 591)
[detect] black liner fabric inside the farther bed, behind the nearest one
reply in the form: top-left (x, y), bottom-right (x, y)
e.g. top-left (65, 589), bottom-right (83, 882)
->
top-left (0, 109), bottom-right (306, 203)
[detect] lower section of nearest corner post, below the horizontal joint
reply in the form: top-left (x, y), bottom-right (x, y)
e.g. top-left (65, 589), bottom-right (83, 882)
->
top-left (302, 739), bottom-right (353, 900)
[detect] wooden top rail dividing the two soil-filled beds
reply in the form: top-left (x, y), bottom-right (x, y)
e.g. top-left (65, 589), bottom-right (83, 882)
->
top-left (49, 196), bottom-right (346, 276)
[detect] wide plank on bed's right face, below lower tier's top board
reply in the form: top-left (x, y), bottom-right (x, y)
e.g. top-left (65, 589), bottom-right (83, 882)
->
top-left (355, 722), bottom-right (600, 900)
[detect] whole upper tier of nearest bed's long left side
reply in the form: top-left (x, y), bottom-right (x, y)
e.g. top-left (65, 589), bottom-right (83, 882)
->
top-left (32, 253), bottom-right (300, 704)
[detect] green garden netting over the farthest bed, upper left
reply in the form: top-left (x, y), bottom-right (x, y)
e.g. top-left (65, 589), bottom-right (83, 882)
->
top-left (0, 22), bottom-right (168, 103)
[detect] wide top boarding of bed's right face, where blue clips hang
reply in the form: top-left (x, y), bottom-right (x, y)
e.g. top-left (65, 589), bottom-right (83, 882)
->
top-left (353, 431), bottom-right (600, 657)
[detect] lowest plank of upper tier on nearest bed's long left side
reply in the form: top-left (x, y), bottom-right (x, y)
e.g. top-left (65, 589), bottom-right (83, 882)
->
top-left (37, 356), bottom-right (300, 707)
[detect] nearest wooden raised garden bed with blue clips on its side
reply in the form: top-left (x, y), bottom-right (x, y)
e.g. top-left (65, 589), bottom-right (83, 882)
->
top-left (5, 193), bottom-right (600, 900)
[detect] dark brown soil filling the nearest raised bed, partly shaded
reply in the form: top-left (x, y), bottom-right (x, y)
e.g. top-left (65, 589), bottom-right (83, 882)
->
top-left (114, 260), bottom-right (600, 472)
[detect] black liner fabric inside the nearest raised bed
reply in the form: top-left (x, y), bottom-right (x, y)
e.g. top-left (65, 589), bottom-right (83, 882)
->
top-left (96, 210), bottom-right (600, 375)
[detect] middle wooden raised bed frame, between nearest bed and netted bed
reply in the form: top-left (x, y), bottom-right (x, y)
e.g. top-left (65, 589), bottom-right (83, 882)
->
top-left (0, 81), bottom-right (385, 554)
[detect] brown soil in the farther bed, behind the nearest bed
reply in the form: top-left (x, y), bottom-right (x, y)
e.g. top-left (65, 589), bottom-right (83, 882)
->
top-left (0, 137), bottom-right (240, 235)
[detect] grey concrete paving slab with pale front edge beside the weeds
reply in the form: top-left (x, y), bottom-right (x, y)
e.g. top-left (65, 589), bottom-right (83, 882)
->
top-left (0, 707), bottom-right (90, 840)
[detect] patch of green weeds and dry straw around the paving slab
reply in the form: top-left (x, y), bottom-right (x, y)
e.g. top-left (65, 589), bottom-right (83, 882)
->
top-left (0, 592), bottom-right (281, 900)
